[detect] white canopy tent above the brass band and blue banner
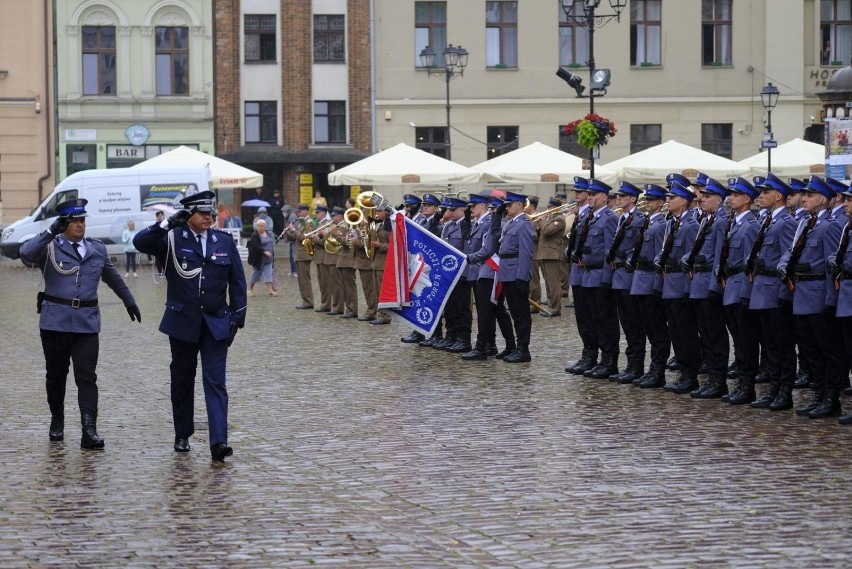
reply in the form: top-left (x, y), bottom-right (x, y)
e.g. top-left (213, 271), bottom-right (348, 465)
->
top-left (328, 143), bottom-right (481, 186)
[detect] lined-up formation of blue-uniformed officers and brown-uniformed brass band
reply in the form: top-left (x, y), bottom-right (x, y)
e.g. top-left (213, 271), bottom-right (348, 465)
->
top-left (287, 173), bottom-right (852, 424)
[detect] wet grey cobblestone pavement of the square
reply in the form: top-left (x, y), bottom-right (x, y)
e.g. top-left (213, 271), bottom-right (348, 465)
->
top-left (0, 260), bottom-right (852, 568)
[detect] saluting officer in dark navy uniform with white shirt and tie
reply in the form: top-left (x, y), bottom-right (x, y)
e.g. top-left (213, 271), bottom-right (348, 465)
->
top-left (133, 191), bottom-right (247, 461)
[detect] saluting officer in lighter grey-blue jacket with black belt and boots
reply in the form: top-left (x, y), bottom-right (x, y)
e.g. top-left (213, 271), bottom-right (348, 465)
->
top-left (21, 199), bottom-right (142, 449)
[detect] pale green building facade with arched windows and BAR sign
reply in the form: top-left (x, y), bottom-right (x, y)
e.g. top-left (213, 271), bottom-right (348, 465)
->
top-left (55, 0), bottom-right (215, 185)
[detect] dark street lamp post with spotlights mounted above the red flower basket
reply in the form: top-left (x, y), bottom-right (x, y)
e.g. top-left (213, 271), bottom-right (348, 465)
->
top-left (556, 0), bottom-right (628, 178)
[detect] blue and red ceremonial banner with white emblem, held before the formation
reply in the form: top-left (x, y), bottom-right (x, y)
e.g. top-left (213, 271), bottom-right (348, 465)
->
top-left (379, 213), bottom-right (467, 337)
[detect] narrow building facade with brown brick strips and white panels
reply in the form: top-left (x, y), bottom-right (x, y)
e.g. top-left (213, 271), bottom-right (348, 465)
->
top-left (215, 0), bottom-right (373, 209)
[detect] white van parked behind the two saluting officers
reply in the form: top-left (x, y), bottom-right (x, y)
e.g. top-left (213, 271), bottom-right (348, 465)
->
top-left (0, 166), bottom-right (210, 259)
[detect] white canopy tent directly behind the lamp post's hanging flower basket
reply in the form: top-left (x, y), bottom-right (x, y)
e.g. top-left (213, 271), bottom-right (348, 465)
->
top-left (471, 142), bottom-right (616, 185)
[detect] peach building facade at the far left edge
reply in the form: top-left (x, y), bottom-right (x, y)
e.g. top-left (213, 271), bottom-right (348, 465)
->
top-left (0, 0), bottom-right (56, 225)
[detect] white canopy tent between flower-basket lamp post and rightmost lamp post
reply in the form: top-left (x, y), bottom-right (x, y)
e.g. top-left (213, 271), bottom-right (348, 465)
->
top-left (606, 140), bottom-right (749, 184)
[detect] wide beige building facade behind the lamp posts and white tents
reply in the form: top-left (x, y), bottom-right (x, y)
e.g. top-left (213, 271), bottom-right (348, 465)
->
top-left (375, 0), bottom-right (836, 199)
